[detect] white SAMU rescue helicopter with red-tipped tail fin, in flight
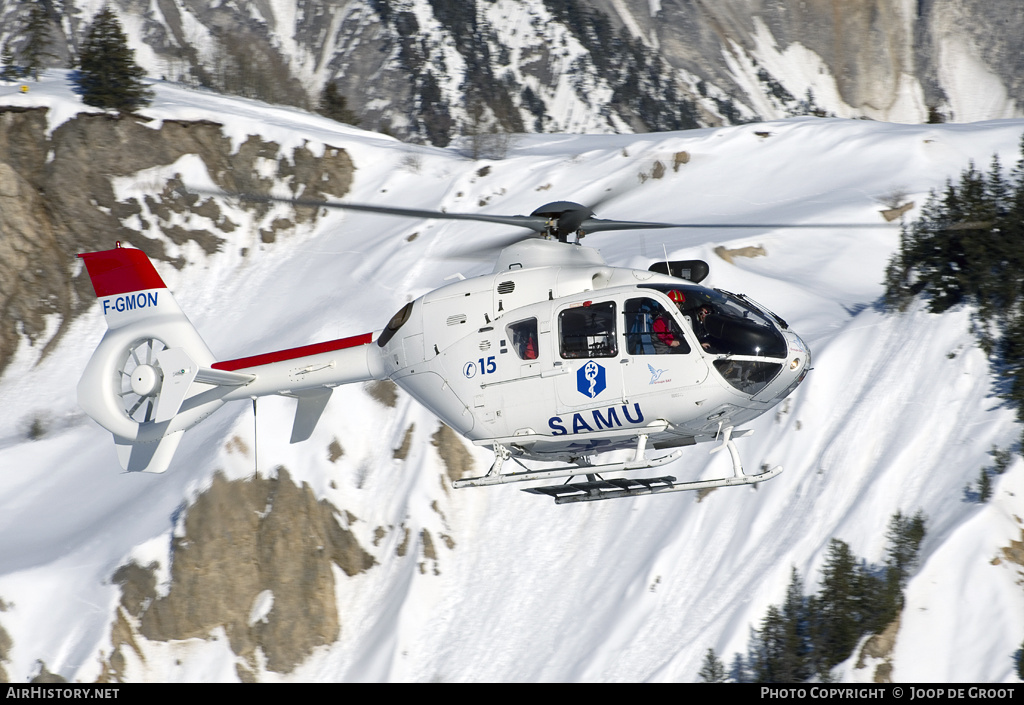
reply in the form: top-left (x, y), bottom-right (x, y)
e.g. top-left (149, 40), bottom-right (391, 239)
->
top-left (78, 194), bottom-right (819, 503)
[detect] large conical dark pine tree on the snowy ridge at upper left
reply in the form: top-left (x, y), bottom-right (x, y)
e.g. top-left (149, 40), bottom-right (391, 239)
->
top-left (77, 7), bottom-right (153, 113)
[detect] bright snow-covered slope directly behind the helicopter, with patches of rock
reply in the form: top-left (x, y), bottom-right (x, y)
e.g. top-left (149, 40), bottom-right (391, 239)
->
top-left (0, 73), bottom-right (1024, 682)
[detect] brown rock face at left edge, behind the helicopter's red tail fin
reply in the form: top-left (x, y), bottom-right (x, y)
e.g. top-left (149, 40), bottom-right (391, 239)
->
top-left (0, 108), bottom-right (353, 373)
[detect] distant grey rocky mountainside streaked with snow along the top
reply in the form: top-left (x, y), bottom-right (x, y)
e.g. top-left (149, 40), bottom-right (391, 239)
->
top-left (0, 0), bottom-right (1024, 147)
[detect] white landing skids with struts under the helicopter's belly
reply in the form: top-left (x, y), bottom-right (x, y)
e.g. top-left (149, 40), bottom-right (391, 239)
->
top-left (453, 426), bottom-right (782, 504)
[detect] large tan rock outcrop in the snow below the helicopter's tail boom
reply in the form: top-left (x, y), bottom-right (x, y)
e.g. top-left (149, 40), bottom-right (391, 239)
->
top-left (112, 468), bottom-right (376, 672)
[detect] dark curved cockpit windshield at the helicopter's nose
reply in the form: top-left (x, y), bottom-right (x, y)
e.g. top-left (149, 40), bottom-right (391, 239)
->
top-left (640, 284), bottom-right (787, 358)
